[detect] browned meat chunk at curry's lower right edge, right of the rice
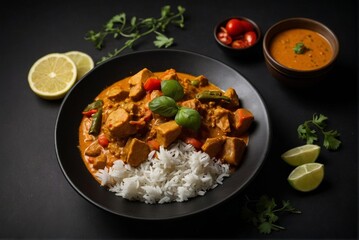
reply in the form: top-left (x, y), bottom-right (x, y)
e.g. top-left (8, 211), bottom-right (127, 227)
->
top-left (218, 137), bottom-right (247, 167)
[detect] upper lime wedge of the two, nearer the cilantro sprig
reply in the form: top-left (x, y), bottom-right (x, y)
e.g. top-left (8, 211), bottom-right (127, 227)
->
top-left (281, 144), bottom-right (320, 167)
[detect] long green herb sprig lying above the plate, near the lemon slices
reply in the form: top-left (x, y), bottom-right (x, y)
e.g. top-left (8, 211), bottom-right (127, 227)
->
top-left (85, 5), bottom-right (186, 64)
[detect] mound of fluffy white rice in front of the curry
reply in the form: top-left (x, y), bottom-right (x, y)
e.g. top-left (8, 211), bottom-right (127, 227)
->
top-left (96, 141), bottom-right (229, 204)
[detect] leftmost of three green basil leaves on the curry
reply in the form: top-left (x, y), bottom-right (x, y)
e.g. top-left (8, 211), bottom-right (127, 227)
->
top-left (148, 96), bottom-right (178, 117)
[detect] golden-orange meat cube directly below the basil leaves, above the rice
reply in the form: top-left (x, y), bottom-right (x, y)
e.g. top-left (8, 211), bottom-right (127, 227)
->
top-left (156, 120), bottom-right (182, 148)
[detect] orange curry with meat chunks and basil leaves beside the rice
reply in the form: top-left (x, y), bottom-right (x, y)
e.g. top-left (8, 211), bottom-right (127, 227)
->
top-left (79, 68), bottom-right (254, 181)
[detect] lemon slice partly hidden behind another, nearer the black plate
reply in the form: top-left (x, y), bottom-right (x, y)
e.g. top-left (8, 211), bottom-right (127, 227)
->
top-left (65, 51), bottom-right (95, 80)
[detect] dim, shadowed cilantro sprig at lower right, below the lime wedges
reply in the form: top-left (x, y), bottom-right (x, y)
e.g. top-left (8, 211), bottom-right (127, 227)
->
top-left (241, 195), bottom-right (301, 234)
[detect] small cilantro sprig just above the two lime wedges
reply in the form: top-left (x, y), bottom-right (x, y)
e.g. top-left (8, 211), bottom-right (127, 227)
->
top-left (297, 114), bottom-right (341, 150)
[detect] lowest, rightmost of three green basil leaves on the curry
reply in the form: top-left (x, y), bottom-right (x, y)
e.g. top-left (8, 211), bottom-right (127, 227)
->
top-left (175, 107), bottom-right (201, 131)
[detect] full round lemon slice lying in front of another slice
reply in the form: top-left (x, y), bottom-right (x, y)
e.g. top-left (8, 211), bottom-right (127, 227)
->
top-left (28, 53), bottom-right (77, 100)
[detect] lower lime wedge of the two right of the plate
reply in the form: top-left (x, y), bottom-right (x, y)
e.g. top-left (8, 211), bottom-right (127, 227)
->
top-left (288, 163), bottom-right (324, 192)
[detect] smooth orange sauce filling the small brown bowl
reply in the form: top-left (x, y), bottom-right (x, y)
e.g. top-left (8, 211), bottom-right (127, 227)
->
top-left (269, 28), bottom-right (333, 71)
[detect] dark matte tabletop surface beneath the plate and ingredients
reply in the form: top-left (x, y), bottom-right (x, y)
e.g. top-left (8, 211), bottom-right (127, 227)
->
top-left (0, 0), bottom-right (358, 239)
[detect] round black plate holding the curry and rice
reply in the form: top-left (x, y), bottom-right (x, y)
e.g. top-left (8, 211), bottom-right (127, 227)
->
top-left (55, 50), bottom-right (270, 220)
